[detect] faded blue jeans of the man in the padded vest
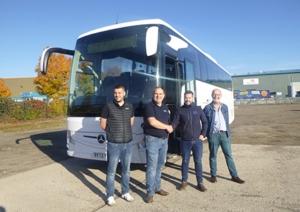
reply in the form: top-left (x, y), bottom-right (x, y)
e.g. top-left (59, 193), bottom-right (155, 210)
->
top-left (106, 142), bottom-right (132, 197)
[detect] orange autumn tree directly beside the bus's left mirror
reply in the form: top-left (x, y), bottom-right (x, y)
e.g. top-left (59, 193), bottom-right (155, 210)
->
top-left (34, 49), bottom-right (72, 99)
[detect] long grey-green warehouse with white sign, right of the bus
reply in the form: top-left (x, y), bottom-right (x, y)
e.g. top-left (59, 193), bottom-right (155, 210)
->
top-left (231, 69), bottom-right (300, 97)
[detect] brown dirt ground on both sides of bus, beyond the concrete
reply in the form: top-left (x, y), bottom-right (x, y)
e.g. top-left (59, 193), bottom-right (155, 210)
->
top-left (0, 104), bottom-right (300, 178)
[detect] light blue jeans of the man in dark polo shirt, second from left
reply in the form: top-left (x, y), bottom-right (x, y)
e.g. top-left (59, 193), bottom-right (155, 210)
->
top-left (145, 135), bottom-right (168, 196)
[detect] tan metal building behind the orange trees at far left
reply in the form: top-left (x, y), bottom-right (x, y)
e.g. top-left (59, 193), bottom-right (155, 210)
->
top-left (2, 77), bottom-right (36, 98)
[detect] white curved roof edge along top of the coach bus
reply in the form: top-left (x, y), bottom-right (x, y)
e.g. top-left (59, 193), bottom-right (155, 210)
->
top-left (78, 19), bottom-right (229, 74)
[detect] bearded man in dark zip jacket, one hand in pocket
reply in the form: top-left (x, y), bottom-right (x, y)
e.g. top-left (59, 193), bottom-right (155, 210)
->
top-left (171, 91), bottom-right (208, 192)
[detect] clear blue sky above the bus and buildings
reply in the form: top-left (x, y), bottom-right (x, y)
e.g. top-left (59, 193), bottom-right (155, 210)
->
top-left (0, 0), bottom-right (300, 78)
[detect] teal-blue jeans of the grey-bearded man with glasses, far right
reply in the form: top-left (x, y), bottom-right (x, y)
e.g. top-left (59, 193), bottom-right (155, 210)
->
top-left (208, 132), bottom-right (238, 177)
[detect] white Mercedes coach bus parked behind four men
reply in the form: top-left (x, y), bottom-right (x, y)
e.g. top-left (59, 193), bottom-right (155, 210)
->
top-left (40, 19), bottom-right (234, 163)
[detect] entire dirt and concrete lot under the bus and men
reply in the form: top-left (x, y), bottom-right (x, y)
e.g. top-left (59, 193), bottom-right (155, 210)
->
top-left (0, 104), bottom-right (300, 212)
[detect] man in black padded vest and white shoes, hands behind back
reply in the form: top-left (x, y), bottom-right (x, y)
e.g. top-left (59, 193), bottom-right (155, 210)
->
top-left (100, 85), bottom-right (134, 206)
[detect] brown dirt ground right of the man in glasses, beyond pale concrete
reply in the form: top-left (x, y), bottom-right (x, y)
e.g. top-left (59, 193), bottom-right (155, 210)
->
top-left (231, 104), bottom-right (300, 146)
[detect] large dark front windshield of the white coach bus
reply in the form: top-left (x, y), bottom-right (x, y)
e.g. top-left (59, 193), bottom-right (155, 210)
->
top-left (68, 26), bottom-right (158, 117)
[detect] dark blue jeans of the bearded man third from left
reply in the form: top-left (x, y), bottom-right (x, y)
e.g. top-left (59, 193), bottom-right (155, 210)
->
top-left (180, 139), bottom-right (203, 184)
